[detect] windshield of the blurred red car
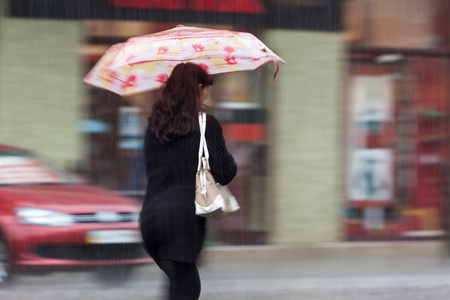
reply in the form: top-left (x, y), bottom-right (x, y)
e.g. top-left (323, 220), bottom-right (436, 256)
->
top-left (0, 149), bottom-right (84, 185)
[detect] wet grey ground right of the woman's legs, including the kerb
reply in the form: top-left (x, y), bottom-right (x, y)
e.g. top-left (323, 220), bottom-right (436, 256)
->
top-left (199, 241), bottom-right (450, 300)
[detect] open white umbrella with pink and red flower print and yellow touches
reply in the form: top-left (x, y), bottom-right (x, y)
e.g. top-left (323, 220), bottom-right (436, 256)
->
top-left (84, 25), bottom-right (285, 96)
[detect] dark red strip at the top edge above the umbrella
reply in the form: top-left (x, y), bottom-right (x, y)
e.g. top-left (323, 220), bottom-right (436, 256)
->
top-left (108, 0), bottom-right (267, 14)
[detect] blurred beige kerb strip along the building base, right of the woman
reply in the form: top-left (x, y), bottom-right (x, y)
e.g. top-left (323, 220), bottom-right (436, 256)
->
top-left (203, 241), bottom-right (447, 260)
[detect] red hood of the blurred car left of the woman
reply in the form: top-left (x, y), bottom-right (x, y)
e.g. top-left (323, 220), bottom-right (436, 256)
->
top-left (0, 185), bottom-right (141, 214)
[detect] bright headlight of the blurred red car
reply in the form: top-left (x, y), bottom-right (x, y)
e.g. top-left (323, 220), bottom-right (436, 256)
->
top-left (16, 207), bottom-right (74, 227)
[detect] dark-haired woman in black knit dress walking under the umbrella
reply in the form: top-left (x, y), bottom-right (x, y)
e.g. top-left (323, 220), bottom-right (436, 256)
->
top-left (140, 63), bottom-right (237, 300)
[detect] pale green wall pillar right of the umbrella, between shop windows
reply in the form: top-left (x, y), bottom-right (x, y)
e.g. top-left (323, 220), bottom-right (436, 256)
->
top-left (263, 30), bottom-right (343, 244)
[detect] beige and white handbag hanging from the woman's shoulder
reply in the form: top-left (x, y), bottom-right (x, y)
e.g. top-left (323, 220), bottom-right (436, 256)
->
top-left (195, 112), bottom-right (240, 220)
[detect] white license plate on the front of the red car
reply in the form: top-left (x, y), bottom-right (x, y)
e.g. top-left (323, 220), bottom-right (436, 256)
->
top-left (86, 230), bottom-right (142, 244)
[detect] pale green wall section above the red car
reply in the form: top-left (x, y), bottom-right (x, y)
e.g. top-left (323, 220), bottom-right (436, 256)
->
top-left (0, 18), bottom-right (82, 164)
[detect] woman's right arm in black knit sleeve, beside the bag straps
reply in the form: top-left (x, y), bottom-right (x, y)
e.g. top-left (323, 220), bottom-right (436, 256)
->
top-left (205, 115), bottom-right (237, 185)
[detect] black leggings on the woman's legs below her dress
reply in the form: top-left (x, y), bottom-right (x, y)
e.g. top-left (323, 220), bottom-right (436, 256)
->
top-left (157, 260), bottom-right (201, 300)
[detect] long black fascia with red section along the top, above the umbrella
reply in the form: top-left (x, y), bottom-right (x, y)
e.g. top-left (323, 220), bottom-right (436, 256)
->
top-left (10, 0), bottom-right (341, 31)
